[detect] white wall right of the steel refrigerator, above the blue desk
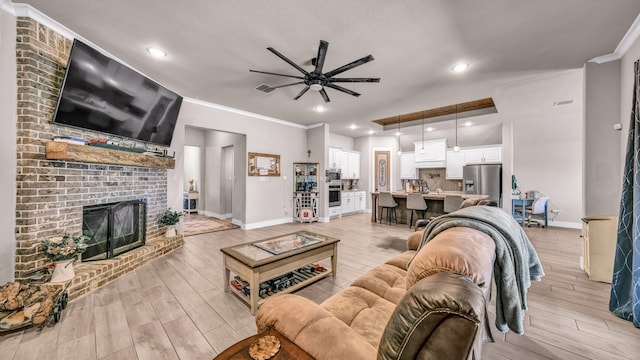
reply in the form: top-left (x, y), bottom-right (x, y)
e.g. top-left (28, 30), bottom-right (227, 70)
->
top-left (496, 69), bottom-right (584, 227)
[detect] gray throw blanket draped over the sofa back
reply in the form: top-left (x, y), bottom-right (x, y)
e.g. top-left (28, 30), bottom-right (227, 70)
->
top-left (418, 206), bottom-right (544, 335)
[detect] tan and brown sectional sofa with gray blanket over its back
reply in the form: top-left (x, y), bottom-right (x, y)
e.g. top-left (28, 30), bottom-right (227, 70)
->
top-left (256, 206), bottom-right (543, 360)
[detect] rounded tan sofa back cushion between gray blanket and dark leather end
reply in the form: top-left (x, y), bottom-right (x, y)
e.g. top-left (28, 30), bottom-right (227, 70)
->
top-left (406, 227), bottom-right (495, 289)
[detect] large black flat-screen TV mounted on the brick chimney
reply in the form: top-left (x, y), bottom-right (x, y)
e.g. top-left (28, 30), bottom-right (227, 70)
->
top-left (53, 40), bottom-right (182, 146)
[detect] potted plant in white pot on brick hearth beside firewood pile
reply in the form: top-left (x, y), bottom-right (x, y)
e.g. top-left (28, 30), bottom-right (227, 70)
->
top-left (40, 233), bottom-right (90, 282)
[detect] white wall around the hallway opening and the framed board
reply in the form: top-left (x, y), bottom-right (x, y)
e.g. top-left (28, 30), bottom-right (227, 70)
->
top-left (168, 100), bottom-right (307, 229)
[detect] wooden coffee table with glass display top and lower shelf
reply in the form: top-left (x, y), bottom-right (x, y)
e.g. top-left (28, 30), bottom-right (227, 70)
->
top-left (220, 231), bottom-right (340, 314)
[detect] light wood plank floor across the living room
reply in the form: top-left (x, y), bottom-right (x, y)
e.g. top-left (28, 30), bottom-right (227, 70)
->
top-left (0, 214), bottom-right (640, 360)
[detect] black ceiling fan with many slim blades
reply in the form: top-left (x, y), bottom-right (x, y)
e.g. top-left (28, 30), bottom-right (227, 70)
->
top-left (249, 40), bottom-right (380, 102)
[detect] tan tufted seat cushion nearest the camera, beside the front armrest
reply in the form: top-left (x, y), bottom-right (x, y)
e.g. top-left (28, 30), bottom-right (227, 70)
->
top-left (320, 286), bottom-right (396, 348)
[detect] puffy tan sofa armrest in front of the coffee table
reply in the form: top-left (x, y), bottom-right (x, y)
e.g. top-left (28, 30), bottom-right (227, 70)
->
top-left (256, 294), bottom-right (376, 360)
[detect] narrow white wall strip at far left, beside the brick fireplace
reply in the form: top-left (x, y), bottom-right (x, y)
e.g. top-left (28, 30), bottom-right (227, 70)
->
top-left (0, 10), bottom-right (17, 284)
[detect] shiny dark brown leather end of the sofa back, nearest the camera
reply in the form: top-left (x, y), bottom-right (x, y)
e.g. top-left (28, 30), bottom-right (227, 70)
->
top-left (378, 272), bottom-right (485, 360)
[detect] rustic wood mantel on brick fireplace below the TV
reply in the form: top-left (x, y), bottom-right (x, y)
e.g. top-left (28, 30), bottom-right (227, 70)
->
top-left (45, 141), bottom-right (176, 169)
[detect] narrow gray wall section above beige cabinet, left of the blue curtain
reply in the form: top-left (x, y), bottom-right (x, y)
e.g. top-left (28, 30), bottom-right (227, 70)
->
top-left (583, 61), bottom-right (622, 216)
